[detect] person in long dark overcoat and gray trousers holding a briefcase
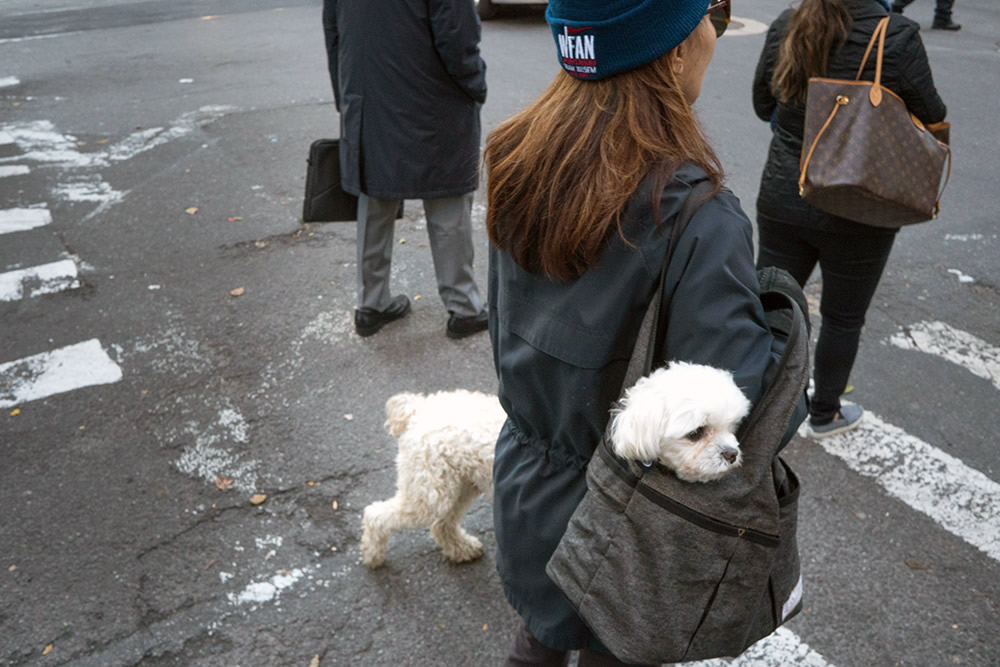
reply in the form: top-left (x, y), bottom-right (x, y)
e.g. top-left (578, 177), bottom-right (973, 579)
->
top-left (323, 0), bottom-right (487, 338)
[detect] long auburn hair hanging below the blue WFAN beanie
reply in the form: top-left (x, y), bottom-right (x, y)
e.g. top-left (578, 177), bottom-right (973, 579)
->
top-left (484, 55), bottom-right (722, 280)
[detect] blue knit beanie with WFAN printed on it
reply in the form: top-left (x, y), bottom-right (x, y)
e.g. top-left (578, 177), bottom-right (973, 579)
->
top-left (545, 0), bottom-right (708, 80)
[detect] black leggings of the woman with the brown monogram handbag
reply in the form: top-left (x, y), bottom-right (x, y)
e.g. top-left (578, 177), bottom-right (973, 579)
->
top-left (757, 220), bottom-right (896, 425)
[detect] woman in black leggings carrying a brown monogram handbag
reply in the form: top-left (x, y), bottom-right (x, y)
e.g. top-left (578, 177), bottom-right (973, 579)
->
top-left (753, 0), bottom-right (946, 437)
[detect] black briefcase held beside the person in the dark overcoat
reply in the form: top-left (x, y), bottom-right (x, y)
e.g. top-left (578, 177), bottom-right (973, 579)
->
top-left (302, 139), bottom-right (403, 222)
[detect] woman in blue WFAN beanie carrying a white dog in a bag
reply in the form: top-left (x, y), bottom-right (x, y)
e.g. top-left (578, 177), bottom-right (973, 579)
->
top-left (485, 0), bottom-right (804, 665)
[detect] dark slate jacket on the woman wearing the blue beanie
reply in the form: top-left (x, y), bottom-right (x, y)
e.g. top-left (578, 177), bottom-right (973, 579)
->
top-left (489, 166), bottom-right (788, 649)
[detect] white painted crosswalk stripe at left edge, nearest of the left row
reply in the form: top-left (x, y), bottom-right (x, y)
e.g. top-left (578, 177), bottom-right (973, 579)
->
top-left (0, 338), bottom-right (122, 408)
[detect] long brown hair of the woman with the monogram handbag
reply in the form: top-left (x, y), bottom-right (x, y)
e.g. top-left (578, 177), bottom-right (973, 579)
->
top-left (771, 0), bottom-right (852, 103)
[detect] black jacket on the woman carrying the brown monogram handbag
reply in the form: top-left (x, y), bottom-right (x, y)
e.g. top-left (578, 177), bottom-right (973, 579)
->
top-left (753, 0), bottom-right (947, 234)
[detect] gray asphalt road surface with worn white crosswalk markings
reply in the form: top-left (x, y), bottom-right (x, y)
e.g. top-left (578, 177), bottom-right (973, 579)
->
top-left (0, 0), bottom-right (1000, 667)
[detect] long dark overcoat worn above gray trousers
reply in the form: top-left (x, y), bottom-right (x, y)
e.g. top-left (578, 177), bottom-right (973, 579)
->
top-left (323, 0), bottom-right (486, 199)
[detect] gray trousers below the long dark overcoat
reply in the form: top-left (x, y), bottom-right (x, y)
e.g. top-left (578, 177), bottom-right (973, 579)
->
top-left (358, 192), bottom-right (483, 317)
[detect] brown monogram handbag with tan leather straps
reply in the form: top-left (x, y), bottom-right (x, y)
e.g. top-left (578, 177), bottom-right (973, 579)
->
top-left (799, 16), bottom-right (951, 228)
